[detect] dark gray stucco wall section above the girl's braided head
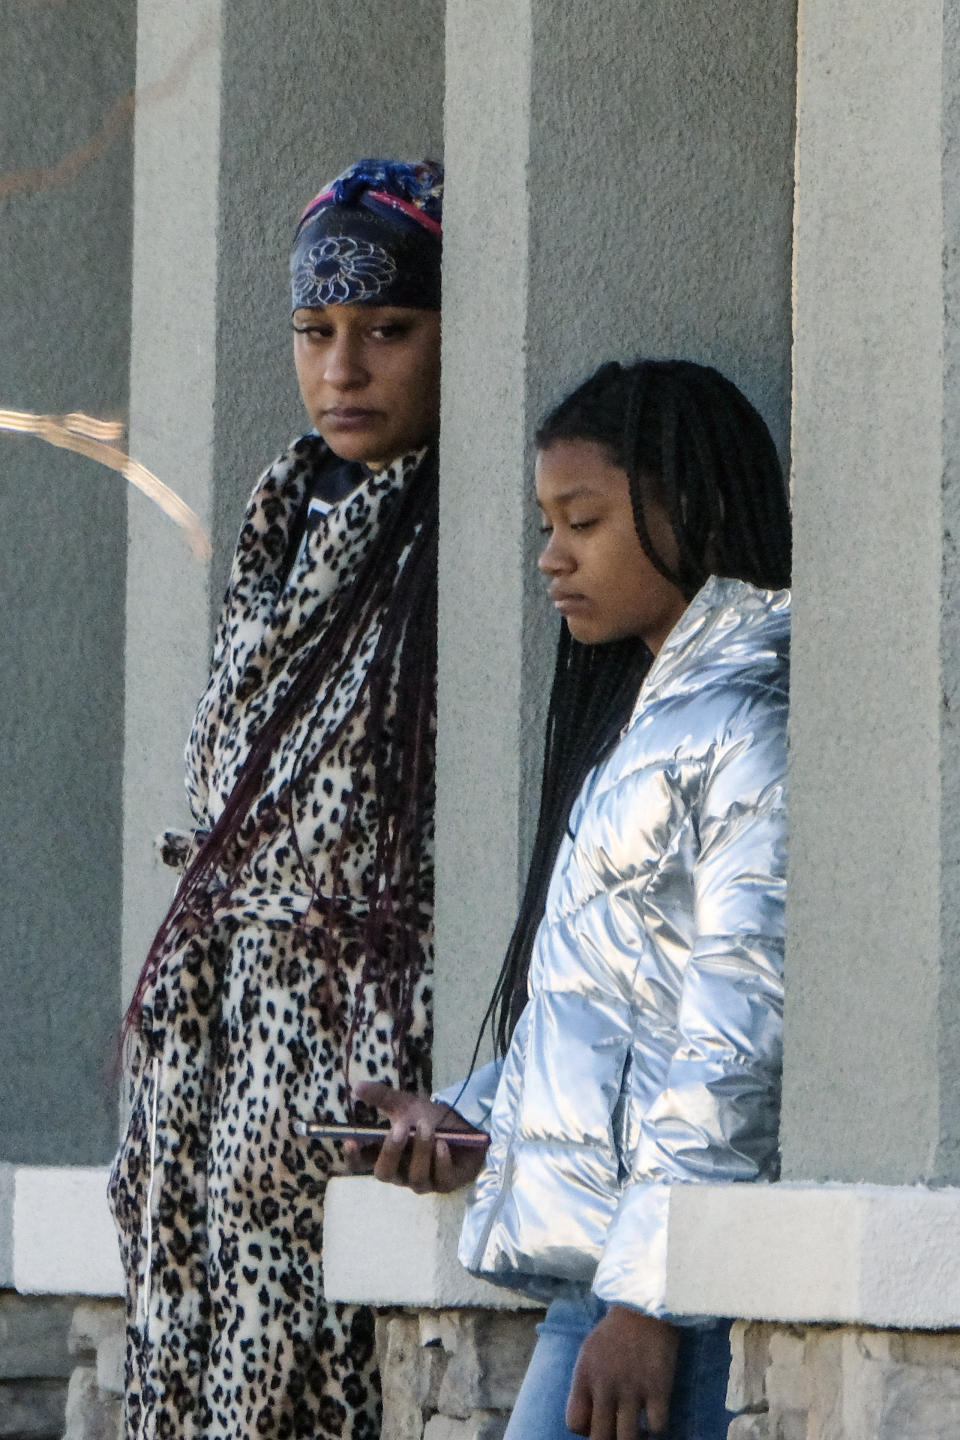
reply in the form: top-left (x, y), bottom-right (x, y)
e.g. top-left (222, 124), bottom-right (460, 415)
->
top-left (528, 0), bottom-right (796, 459)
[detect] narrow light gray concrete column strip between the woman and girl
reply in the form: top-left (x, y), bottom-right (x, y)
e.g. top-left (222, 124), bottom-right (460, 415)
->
top-left (433, 0), bottom-right (543, 1083)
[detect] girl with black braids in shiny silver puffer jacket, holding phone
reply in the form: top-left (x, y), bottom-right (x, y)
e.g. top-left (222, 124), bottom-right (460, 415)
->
top-left (358, 361), bottom-right (790, 1440)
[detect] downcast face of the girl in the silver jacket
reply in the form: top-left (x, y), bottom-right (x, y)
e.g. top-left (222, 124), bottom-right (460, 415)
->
top-left (537, 441), bottom-right (687, 655)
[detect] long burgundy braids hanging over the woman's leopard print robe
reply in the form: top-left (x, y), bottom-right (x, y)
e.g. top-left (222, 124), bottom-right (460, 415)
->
top-left (122, 441), bottom-right (438, 1077)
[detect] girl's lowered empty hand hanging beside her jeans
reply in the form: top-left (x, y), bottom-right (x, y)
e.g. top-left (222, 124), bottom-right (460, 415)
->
top-left (567, 1305), bottom-right (679, 1440)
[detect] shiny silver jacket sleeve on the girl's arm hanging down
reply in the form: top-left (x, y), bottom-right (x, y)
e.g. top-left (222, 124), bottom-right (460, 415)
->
top-left (594, 693), bottom-right (786, 1316)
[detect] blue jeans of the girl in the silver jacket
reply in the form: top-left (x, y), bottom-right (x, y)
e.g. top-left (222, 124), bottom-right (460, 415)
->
top-left (504, 1293), bottom-right (734, 1440)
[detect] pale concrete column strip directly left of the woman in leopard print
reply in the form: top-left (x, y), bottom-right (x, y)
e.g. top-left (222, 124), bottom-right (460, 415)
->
top-left (124, 0), bottom-right (220, 994)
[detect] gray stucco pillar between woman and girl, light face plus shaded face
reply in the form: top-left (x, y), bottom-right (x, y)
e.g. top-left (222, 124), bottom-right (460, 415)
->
top-left (436, 0), bottom-right (794, 1080)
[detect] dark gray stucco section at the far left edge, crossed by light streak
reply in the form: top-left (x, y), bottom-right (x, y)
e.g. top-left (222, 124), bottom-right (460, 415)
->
top-left (0, 0), bottom-right (135, 1164)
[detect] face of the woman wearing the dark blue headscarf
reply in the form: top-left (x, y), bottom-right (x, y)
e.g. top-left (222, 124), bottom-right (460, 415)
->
top-left (294, 305), bottom-right (440, 468)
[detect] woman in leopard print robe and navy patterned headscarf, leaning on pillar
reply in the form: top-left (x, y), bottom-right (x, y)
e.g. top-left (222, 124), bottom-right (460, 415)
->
top-left (111, 160), bottom-right (442, 1440)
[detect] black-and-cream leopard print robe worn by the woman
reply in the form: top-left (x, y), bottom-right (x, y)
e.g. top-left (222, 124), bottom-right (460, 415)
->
top-left (109, 435), bottom-right (432, 1440)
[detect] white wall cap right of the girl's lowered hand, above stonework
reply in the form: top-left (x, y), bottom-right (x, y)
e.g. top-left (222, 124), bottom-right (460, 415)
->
top-left (666, 1184), bottom-right (960, 1329)
